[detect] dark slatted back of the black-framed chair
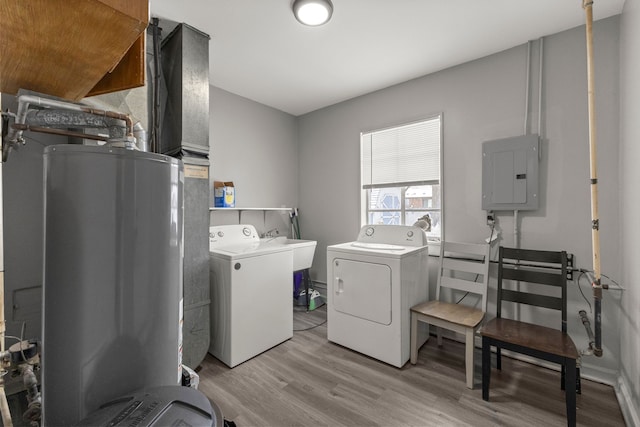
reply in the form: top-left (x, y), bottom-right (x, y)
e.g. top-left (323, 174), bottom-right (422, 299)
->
top-left (497, 246), bottom-right (567, 332)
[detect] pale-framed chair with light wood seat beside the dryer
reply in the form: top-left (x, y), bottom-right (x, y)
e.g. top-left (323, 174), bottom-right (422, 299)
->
top-left (411, 242), bottom-right (490, 388)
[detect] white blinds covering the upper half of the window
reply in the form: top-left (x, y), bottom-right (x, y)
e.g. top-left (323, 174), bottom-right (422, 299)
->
top-left (361, 116), bottom-right (441, 188)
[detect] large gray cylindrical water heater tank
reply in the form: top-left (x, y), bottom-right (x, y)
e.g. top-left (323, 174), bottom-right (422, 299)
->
top-left (42, 145), bottom-right (184, 425)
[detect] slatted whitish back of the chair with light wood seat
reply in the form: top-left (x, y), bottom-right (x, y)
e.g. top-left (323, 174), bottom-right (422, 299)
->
top-left (436, 242), bottom-right (490, 311)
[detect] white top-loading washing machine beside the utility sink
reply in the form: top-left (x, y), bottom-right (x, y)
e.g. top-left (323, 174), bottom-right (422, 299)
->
top-left (209, 224), bottom-right (293, 368)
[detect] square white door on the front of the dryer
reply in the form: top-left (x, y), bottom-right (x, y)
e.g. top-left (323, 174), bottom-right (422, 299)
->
top-left (331, 258), bottom-right (391, 325)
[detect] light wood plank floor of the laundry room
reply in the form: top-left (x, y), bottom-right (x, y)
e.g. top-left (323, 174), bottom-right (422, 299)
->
top-left (198, 306), bottom-right (624, 427)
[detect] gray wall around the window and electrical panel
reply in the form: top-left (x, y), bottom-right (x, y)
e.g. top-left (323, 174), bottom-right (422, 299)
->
top-left (299, 17), bottom-right (620, 383)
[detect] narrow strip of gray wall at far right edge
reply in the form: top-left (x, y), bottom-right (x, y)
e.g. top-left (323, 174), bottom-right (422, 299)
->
top-left (618, 0), bottom-right (640, 426)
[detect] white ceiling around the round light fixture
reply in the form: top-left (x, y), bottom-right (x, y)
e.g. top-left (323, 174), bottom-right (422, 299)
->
top-left (151, 0), bottom-right (624, 116)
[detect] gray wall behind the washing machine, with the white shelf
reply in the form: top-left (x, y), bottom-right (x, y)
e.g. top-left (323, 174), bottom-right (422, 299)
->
top-left (209, 87), bottom-right (299, 234)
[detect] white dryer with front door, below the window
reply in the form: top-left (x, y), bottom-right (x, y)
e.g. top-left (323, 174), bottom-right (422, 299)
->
top-left (327, 225), bottom-right (429, 368)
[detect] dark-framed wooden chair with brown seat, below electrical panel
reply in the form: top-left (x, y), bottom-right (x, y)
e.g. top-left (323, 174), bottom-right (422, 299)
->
top-left (480, 247), bottom-right (580, 426)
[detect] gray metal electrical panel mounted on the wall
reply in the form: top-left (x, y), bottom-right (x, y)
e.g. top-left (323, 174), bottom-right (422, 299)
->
top-left (482, 135), bottom-right (540, 211)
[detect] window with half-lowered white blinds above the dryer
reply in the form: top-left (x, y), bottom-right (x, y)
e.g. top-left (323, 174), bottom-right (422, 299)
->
top-left (360, 115), bottom-right (442, 239)
